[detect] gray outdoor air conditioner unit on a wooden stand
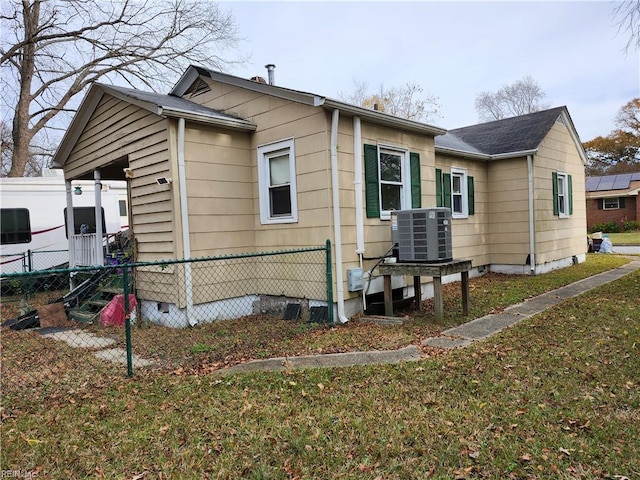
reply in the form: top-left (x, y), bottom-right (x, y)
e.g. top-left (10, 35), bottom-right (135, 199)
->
top-left (391, 208), bottom-right (453, 263)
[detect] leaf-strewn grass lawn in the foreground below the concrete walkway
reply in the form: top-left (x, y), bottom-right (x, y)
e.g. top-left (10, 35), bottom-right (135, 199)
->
top-left (0, 255), bottom-right (640, 479)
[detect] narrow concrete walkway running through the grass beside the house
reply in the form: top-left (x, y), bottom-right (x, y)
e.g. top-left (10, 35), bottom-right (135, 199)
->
top-left (216, 259), bottom-right (640, 375)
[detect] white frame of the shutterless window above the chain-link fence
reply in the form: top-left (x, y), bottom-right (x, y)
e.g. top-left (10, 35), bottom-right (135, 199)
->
top-left (257, 138), bottom-right (298, 225)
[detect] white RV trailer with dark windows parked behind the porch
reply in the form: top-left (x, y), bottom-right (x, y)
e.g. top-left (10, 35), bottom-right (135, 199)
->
top-left (0, 170), bottom-right (128, 273)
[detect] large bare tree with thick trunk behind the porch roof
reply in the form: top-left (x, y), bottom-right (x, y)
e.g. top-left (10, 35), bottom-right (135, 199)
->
top-left (0, 0), bottom-right (238, 177)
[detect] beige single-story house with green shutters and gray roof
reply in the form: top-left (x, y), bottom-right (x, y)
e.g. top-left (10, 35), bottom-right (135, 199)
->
top-left (55, 67), bottom-right (586, 322)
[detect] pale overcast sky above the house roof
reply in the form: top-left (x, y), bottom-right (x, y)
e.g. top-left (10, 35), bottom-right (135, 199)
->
top-left (222, 1), bottom-right (640, 141)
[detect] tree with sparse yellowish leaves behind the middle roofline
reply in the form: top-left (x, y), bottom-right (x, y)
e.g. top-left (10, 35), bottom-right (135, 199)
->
top-left (338, 80), bottom-right (440, 122)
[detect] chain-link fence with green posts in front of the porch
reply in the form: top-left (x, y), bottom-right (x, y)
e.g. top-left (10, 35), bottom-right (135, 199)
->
top-left (0, 241), bottom-right (333, 400)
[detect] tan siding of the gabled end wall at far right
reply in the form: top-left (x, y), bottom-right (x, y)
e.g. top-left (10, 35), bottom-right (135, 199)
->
top-left (534, 123), bottom-right (587, 264)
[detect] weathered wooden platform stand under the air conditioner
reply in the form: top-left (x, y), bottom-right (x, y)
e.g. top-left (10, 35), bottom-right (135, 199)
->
top-left (378, 259), bottom-right (471, 320)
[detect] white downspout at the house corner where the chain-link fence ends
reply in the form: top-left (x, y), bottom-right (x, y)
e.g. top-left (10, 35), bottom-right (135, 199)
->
top-left (329, 108), bottom-right (349, 323)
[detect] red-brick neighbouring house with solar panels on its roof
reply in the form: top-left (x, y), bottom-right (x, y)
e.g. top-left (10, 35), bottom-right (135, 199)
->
top-left (586, 172), bottom-right (640, 229)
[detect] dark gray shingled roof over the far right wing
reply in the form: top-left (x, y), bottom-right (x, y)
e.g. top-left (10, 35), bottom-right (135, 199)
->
top-left (435, 107), bottom-right (566, 155)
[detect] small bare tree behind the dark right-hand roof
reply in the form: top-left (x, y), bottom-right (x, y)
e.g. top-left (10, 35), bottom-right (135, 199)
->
top-left (476, 75), bottom-right (548, 121)
